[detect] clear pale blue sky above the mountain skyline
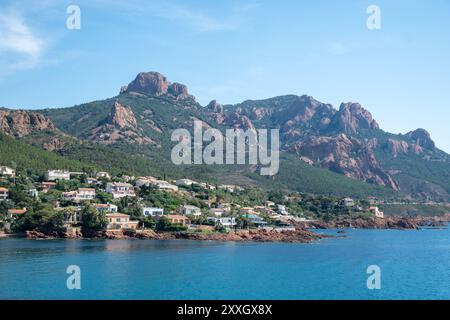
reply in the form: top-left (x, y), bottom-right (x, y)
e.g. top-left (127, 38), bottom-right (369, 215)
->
top-left (0, 0), bottom-right (450, 152)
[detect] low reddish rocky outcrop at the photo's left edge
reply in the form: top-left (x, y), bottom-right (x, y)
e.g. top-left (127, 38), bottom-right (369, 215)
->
top-left (0, 109), bottom-right (56, 137)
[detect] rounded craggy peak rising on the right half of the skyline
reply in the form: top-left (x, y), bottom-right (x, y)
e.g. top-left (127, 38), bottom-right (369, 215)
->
top-left (335, 102), bottom-right (380, 134)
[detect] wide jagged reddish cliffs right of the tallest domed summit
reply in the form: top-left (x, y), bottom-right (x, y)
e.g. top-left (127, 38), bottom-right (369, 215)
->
top-left (205, 90), bottom-right (442, 194)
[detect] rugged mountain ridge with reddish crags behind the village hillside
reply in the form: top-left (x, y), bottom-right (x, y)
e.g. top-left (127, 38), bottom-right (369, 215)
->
top-left (1, 72), bottom-right (450, 199)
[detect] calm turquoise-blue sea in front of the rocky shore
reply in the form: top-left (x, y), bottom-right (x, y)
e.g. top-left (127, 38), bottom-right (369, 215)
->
top-left (0, 230), bottom-right (450, 299)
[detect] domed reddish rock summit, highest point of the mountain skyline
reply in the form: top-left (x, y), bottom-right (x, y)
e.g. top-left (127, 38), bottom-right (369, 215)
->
top-left (120, 72), bottom-right (195, 99)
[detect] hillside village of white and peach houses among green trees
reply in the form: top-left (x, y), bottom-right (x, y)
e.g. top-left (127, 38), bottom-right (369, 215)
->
top-left (0, 166), bottom-right (384, 239)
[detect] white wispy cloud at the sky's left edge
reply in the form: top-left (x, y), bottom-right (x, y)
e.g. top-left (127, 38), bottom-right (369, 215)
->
top-left (0, 12), bottom-right (44, 69)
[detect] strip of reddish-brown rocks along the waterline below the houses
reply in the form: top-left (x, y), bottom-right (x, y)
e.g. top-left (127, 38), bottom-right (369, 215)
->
top-left (0, 215), bottom-right (450, 243)
